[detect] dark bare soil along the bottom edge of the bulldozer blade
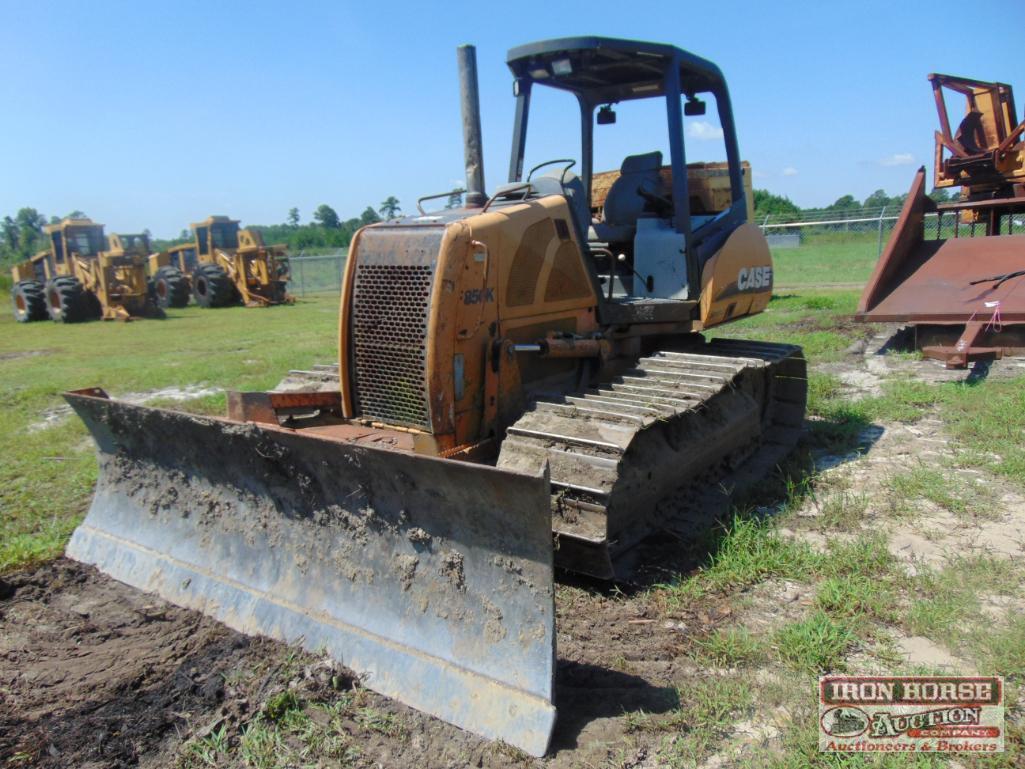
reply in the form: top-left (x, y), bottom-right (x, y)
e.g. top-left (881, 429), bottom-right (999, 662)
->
top-left (0, 559), bottom-right (733, 769)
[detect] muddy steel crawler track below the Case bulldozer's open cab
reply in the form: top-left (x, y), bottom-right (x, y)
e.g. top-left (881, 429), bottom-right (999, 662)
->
top-left (498, 339), bottom-right (808, 578)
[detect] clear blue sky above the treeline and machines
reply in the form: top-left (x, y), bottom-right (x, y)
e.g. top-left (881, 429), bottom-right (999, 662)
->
top-left (0, 0), bottom-right (1025, 237)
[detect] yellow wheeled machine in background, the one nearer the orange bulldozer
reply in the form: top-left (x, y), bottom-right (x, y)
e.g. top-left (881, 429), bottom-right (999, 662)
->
top-left (144, 216), bottom-right (294, 308)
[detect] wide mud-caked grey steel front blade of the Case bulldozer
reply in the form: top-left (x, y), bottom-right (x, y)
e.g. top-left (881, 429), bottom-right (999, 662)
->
top-left (65, 390), bottom-right (555, 756)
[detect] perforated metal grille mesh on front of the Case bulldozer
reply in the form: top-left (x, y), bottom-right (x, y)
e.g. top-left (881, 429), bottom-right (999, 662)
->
top-left (353, 262), bottom-right (434, 429)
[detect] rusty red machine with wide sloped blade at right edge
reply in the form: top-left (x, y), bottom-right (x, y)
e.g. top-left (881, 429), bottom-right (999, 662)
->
top-left (856, 75), bottom-right (1025, 368)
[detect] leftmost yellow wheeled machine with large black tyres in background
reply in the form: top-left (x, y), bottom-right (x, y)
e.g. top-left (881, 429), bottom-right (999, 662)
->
top-left (11, 218), bottom-right (163, 323)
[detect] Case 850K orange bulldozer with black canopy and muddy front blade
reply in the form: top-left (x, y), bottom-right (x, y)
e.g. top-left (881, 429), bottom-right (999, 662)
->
top-left (66, 37), bottom-right (807, 755)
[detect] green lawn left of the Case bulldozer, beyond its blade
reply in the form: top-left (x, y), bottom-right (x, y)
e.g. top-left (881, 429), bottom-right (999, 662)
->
top-left (0, 296), bottom-right (338, 573)
